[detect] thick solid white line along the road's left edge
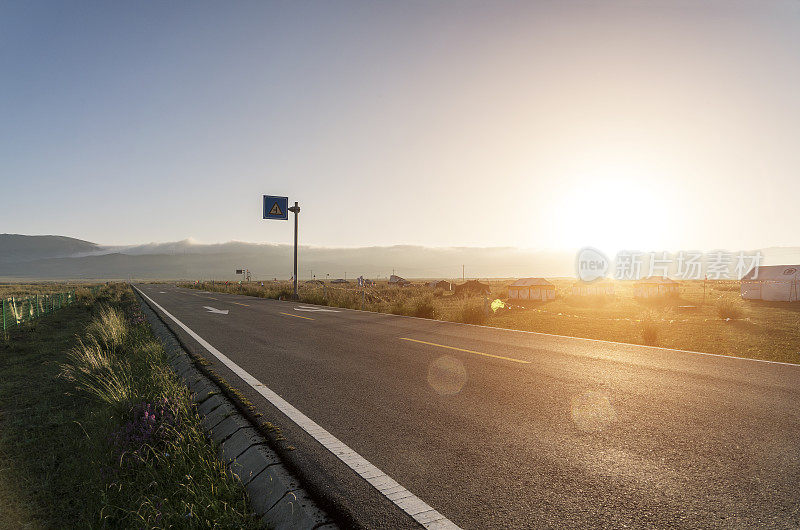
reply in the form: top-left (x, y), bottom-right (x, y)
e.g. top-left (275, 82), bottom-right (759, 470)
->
top-left (134, 286), bottom-right (459, 529)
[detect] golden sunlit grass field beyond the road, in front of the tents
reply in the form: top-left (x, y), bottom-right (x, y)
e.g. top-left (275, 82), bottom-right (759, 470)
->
top-left (180, 279), bottom-right (800, 363)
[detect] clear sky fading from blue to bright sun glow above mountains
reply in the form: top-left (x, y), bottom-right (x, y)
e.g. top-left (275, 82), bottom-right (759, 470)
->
top-left (0, 0), bottom-right (800, 251)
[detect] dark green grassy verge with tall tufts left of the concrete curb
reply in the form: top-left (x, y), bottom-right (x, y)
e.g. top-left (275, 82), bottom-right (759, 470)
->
top-left (0, 286), bottom-right (260, 528)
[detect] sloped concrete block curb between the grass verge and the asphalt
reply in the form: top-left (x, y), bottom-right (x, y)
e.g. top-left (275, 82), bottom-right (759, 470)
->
top-left (134, 291), bottom-right (338, 530)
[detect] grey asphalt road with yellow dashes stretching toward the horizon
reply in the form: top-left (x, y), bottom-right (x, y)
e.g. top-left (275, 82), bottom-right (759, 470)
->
top-left (138, 285), bottom-right (800, 528)
